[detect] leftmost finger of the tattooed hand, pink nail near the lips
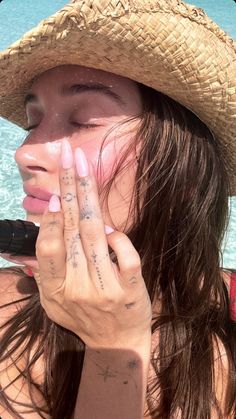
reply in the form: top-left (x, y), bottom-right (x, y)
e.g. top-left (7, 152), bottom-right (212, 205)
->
top-left (36, 202), bottom-right (66, 293)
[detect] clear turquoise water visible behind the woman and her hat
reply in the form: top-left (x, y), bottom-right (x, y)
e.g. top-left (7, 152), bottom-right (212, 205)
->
top-left (0, 0), bottom-right (236, 268)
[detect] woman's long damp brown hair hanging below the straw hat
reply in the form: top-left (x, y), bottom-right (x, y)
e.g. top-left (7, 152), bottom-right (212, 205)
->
top-left (0, 85), bottom-right (236, 419)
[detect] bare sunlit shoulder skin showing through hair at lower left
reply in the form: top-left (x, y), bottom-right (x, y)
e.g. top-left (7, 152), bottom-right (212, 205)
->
top-left (0, 269), bottom-right (50, 419)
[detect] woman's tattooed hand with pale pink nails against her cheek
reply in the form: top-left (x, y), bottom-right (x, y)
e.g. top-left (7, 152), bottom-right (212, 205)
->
top-left (35, 142), bottom-right (152, 348)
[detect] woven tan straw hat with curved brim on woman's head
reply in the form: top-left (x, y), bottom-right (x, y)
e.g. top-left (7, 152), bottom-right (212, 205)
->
top-left (0, 0), bottom-right (236, 194)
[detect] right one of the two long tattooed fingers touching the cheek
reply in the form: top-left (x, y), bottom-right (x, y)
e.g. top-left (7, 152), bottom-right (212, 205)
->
top-left (75, 148), bottom-right (114, 291)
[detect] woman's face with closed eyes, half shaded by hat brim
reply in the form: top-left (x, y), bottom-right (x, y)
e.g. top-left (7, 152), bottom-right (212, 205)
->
top-left (15, 65), bottom-right (142, 229)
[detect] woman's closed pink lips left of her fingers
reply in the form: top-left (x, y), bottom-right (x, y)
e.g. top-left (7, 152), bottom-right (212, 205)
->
top-left (22, 185), bottom-right (52, 214)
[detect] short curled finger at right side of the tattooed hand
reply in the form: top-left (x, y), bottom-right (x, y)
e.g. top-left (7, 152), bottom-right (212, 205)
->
top-left (107, 231), bottom-right (143, 287)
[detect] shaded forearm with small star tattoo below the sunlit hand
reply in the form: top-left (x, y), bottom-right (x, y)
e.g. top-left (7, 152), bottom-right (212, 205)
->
top-left (74, 348), bottom-right (150, 419)
